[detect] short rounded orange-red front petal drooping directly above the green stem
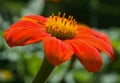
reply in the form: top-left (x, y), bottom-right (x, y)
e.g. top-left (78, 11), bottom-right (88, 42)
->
top-left (43, 37), bottom-right (73, 66)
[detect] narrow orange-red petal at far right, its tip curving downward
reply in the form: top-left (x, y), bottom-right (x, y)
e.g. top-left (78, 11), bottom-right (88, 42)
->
top-left (75, 34), bottom-right (114, 61)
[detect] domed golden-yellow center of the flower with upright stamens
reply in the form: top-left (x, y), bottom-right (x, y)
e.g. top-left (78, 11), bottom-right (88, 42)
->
top-left (46, 13), bottom-right (78, 40)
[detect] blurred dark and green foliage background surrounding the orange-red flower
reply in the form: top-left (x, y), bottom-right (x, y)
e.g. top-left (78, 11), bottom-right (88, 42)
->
top-left (0, 0), bottom-right (120, 83)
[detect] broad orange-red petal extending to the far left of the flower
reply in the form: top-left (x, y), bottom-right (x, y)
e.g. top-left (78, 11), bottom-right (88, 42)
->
top-left (3, 20), bottom-right (48, 47)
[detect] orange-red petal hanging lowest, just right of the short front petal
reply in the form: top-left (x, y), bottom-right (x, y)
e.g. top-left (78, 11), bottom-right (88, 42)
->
top-left (67, 39), bottom-right (102, 72)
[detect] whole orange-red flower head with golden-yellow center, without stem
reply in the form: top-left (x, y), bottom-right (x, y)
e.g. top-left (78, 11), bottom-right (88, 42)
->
top-left (4, 13), bottom-right (114, 72)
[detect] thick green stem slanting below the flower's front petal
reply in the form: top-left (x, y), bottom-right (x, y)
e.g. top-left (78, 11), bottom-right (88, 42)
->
top-left (32, 57), bottom-right (55, 83)
